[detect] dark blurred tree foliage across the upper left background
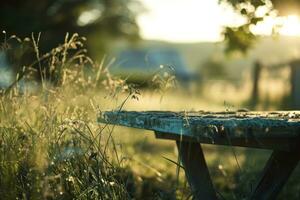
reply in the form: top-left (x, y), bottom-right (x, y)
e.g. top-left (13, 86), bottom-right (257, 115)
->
top-left (0, 0), bottom-right (141, 50)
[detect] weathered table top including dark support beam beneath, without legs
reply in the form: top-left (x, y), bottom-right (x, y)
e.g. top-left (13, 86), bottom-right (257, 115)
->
top-left (98, 111), bottom-right (300, 150)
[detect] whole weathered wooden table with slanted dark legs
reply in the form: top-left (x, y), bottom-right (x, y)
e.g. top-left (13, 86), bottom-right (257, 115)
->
top-left (98, 111), bottom-right (300, 200)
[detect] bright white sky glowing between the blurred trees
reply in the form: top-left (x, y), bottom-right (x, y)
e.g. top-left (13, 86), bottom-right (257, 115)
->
top-left (138, 0), bottom-right (300, 42)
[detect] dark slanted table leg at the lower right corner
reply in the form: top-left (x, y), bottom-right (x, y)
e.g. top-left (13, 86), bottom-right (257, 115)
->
top-left (250, 151), bottom-right (300, 200)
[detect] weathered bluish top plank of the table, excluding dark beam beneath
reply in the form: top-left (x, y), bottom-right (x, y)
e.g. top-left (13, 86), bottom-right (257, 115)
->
top-left (98, 111), bottom-right (300, 138)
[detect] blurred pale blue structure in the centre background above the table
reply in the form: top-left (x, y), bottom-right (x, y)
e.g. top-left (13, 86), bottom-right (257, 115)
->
top-left (109, 48), bottom-right (196, 85)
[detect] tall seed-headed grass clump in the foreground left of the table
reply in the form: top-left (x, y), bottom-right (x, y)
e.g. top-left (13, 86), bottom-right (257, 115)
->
top-left (0, 34), bottom-right (136, 199)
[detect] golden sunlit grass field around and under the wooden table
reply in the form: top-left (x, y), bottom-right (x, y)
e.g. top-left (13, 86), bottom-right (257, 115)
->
top-left (0, 32), bottom-right (300, 199)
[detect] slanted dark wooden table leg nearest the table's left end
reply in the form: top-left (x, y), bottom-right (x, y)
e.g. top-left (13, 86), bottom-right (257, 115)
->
top-left (176, 141), bottom-right (217, 200)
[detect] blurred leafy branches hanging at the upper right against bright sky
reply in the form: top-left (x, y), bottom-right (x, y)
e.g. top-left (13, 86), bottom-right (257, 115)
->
top-left (219, 0), bottom-right (300, 53)
